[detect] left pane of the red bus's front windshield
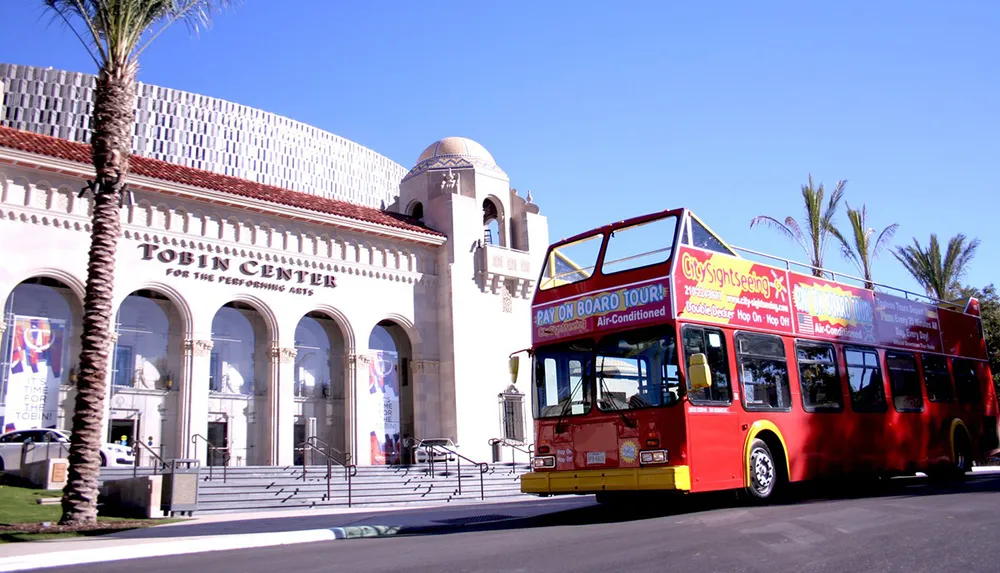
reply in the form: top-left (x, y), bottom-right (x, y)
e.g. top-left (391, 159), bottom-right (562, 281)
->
top-left (535, 346), bottom-right (591, 418)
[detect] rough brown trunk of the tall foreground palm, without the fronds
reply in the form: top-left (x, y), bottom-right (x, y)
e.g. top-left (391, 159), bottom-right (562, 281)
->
top-left (60, 66), bottom-right (136, 525)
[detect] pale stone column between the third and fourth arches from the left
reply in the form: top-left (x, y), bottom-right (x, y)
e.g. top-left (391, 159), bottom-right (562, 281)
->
top-left (266, 344), bottom-right (297, 466)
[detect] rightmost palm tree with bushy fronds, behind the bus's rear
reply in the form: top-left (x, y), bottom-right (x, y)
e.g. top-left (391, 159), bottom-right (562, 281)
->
top-left (892, 233), bottom-right (979, 300)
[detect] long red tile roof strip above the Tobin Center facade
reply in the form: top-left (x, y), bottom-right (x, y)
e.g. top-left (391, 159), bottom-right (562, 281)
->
top-left (0, 126), bottom-right (445, 237)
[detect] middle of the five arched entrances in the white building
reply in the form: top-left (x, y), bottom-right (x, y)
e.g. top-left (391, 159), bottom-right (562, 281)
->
top-left (205, 302), bottom-right (270, 465)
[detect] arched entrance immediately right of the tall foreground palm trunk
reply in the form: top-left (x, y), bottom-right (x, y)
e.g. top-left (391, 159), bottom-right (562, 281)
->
top-left (108, 290), bottom-right (185, 458)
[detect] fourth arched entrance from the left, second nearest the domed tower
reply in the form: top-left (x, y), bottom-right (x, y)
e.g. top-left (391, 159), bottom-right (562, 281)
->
top-left (293, 312), bottom-right (347, 464)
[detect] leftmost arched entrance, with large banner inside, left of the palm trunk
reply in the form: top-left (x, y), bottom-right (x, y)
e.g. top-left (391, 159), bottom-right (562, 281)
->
top-left (0, 277), bottom-right (83, 431)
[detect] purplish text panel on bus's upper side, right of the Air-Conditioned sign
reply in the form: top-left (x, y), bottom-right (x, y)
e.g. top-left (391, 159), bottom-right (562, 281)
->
top-left (875, 293), bottom-right (942, 352)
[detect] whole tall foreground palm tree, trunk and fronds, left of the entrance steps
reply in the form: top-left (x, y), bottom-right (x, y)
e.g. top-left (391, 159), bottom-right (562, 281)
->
top-left (43, 0), bottom-right (228, 525)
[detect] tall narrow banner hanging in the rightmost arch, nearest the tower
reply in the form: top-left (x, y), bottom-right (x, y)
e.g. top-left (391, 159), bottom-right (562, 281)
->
top-left (361, 351), bottom-right (402, 466)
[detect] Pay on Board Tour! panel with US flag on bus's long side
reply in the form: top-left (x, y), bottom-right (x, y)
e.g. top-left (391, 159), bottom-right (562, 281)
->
top-left (788, 273), bottom-right (877, 344)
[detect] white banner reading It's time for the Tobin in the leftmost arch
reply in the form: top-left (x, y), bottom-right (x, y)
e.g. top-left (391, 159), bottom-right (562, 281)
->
top-left (4, 316), bottom-right (66, 431)
